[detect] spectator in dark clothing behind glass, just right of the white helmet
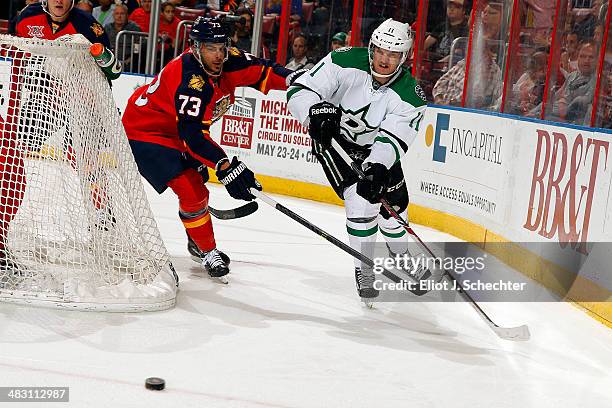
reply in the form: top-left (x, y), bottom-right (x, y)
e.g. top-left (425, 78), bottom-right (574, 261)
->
top-left (425, 0), bottom-right (470, 60)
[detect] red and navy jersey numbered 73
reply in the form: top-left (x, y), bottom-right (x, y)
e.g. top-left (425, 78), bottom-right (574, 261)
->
top-left (123, 48), bottom-right (292, 168)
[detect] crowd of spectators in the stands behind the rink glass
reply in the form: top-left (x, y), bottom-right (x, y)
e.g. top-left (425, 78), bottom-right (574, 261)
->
top-left (0, 0), bottom-right (612, 128)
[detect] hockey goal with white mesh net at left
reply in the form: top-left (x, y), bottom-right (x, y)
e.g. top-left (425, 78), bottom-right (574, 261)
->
top-left (0, 35), bottom-right (176, 311)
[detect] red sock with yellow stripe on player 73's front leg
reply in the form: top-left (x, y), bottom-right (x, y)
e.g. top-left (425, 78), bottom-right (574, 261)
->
top-left (168, 169), bottom-right (217, 251)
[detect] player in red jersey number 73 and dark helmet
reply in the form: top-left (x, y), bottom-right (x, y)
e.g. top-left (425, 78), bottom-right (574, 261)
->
top-left (123, 17), bottom-right (291, 277)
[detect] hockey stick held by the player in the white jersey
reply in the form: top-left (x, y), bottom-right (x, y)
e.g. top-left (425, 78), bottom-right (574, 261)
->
top-left (332, 139), bottom-right (530, 341)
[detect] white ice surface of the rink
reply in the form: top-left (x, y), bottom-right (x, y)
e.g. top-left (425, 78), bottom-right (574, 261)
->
top-left (0, 185), bottom-right (612, 408)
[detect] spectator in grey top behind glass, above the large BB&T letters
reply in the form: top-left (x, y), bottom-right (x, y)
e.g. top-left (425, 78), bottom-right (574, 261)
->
top-left (553, 40), bottom-right (597, 124)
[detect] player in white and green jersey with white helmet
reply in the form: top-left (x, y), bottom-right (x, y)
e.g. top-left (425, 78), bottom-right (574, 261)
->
top-left (287, 19), bottom-right (426, 302)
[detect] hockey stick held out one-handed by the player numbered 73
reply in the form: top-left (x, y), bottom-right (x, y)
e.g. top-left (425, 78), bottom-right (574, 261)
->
top-left (251, 189), bottom-right (426, 296)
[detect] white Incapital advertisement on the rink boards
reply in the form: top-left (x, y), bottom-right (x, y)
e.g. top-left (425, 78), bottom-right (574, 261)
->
top-left (404, 108), bottom-right (513, 224)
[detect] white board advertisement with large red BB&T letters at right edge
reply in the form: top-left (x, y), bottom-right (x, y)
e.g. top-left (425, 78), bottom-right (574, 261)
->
top-left (509, 121), bottom-right (612, 247)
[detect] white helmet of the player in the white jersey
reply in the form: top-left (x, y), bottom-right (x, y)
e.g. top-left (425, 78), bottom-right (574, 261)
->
top-left (368, 18), bottom-right (413, 78)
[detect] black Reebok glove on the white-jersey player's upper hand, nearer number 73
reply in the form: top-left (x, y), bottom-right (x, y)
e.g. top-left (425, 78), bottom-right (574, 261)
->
top-left (308, 102), bottom-right (342, 154)
